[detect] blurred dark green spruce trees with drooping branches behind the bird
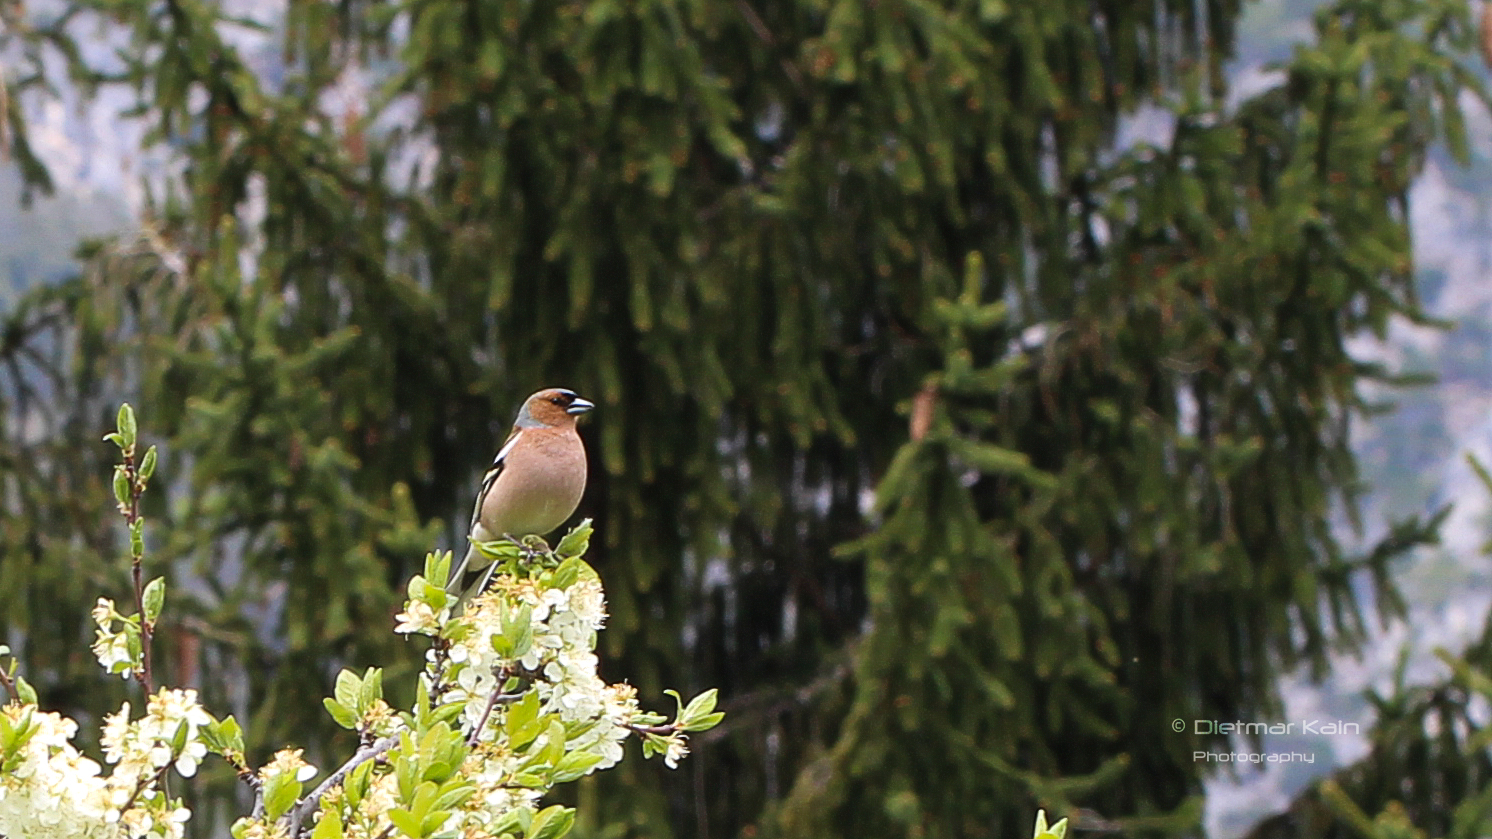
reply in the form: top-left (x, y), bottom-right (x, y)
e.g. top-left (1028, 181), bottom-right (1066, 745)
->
top-left (0, 0), bottom-right (1480, 838)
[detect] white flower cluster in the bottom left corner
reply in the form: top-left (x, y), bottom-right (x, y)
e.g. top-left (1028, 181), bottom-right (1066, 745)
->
top-left (0, 688), bottom-right (210, 839)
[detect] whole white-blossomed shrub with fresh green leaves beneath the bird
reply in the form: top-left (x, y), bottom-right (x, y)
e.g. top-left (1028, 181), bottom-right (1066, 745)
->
top-left (0, 405), bottom-right (724, 839)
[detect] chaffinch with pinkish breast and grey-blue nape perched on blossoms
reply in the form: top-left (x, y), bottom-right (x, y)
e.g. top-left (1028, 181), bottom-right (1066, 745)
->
top-left (446, 388), bottom-right (595, 603)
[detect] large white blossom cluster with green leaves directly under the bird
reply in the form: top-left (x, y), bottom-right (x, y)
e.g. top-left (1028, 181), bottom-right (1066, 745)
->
top-left (365, 537), bottom-right (719, 839)
